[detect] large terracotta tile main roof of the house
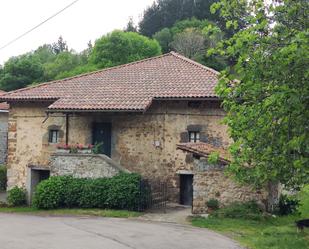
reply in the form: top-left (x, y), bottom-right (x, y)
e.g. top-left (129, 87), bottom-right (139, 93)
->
top-left (0, 52), bottom-right (218, 111)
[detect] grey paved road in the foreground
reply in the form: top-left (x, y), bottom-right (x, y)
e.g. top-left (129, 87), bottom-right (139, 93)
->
top-left (0, 213), bottom-right (240, 249)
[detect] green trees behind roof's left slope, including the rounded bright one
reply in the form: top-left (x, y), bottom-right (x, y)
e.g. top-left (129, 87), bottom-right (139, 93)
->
top-left (0, 31), bottom-right (161, 91)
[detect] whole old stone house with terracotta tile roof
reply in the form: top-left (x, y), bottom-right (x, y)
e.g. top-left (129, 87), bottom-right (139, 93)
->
top-left (0, 52), bottom-right (264, 212)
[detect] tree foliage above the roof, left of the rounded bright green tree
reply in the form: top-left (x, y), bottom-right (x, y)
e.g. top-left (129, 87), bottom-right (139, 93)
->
top-left (0, 37), bottom-right (92, 91)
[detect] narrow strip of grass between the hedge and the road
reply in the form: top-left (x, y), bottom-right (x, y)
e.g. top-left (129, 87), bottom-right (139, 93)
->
top-left (0, 207), bottom-right (142, 218)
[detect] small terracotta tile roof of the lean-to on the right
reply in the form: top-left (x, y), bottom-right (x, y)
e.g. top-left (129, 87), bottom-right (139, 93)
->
top-left (177, 142), bottom-right (230, 164)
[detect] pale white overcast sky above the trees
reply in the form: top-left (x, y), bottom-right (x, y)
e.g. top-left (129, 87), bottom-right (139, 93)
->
top-left (0, 0), bottom-right (154, 64)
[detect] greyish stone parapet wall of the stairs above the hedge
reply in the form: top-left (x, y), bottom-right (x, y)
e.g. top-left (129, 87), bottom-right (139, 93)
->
top-left (50, 153), bottom-right (126, 178)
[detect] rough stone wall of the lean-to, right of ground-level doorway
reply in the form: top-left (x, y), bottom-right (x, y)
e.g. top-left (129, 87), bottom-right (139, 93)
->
top-left (192, 158), bottom-right (267, 213)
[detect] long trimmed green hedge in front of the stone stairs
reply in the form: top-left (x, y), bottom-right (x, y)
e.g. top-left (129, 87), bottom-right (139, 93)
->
top-left (32, 173), bottom-right (141, 210)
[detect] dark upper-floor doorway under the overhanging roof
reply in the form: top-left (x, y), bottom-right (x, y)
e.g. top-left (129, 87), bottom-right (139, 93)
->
top-left (92, 123), bottom-right (112, 157)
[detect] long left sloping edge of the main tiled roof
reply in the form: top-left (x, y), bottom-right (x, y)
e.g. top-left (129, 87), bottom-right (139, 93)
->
top-left (3, 52), bottom-right (172, 96)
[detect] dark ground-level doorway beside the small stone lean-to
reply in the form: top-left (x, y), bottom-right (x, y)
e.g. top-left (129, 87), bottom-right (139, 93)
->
top-left (179, 175), bottom-right (193, 206)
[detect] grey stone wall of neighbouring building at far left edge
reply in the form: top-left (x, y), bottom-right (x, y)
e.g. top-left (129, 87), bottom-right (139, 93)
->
top-left (0, 112), bottom-right (9, 164)
